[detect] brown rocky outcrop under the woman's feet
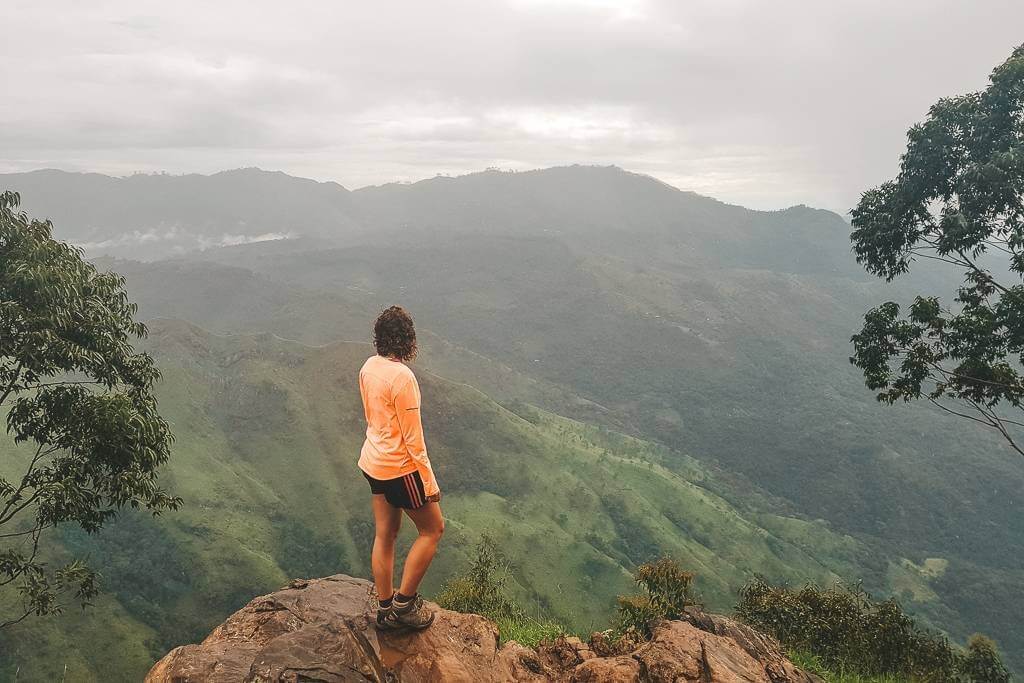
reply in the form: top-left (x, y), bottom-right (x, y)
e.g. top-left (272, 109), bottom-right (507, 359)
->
top-left (145, 574), bottom-right (818, 683)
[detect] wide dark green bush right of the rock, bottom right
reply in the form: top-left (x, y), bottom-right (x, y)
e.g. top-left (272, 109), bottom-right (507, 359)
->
top-left (736, 579), bottom-right (1007, 683)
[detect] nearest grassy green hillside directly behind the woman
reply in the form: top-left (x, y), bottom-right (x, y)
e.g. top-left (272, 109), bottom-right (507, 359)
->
top-left (0, 321), bottom-right (942, 680)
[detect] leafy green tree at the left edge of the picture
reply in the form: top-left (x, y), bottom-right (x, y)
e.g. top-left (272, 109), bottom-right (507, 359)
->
top-left (0, 191), bottom-right (180, 628)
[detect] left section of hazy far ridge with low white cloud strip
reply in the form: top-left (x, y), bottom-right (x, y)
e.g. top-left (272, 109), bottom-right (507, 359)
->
top-left (0, 169), bottom-right (355, 260)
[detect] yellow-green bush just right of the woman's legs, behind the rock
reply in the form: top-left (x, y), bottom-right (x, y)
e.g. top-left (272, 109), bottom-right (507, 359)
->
top-left (437, 535), bottom-right (565, 647)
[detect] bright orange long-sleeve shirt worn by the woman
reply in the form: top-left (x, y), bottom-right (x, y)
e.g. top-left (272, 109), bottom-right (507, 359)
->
top-left (359, 355), bottom-right (440, 496)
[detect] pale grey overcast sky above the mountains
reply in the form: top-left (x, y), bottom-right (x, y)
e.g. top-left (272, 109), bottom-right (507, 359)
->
top-left (0, 0), bottom-right (1024, 212)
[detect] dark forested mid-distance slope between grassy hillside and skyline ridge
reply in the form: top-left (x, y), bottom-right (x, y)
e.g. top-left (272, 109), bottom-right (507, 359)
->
top-left (92, 238), bottom-right (1024, 667)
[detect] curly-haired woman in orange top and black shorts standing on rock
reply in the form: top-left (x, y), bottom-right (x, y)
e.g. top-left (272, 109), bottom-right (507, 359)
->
top-left (359, 306), bottom-right (444, 630)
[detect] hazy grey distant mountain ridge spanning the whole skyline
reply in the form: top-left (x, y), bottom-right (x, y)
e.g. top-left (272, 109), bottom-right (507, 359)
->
top-left (0, 166), bottom-right (853, 270)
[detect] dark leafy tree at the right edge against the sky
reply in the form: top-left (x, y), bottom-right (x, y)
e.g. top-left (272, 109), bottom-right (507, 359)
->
top-left (850, 45), bottom-right (1024, 455)
